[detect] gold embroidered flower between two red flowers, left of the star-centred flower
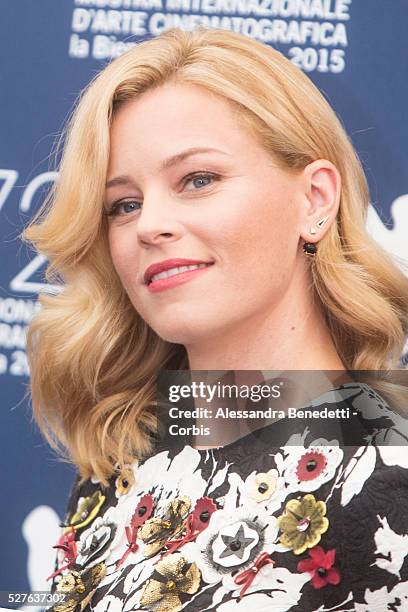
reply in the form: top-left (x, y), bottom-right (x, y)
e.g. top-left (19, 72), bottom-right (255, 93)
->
top-left (139, 496), bottom-right (191, 557)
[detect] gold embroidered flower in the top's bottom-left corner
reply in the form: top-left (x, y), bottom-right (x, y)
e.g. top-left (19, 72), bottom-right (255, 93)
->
top-left (50, 563), bottom-right (106, 612)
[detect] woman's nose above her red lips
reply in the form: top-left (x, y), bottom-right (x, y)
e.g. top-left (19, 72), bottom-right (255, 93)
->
top-left (136, 194), bottom-right (183, 247)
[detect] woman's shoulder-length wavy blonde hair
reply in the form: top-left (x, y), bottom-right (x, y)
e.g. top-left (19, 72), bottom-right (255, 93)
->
top-left (22, 27), bottom-right (408, 485)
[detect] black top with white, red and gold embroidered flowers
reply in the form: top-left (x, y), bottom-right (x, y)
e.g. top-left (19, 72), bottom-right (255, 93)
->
top-left (52, 382), bottom-right (408, 612)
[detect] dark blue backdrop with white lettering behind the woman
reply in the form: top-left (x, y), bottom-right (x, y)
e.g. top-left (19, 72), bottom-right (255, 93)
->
top-left (0, 0), bottom-right (408, 596)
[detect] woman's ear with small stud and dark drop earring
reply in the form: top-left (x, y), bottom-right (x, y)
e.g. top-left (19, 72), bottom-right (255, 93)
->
top-left (301, 159), bottom-right (341, 242)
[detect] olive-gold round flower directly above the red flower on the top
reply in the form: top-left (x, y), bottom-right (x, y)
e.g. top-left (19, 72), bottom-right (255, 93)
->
top-left (278, 494), bottom-right (329, 555)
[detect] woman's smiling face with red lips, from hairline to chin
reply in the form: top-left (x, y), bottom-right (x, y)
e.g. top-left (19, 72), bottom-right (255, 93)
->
top-left (105, 83), bottom-right (304, 346)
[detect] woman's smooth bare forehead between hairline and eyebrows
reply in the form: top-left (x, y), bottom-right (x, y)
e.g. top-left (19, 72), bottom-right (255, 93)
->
top-left (110, 83), bottom-right (254, 164)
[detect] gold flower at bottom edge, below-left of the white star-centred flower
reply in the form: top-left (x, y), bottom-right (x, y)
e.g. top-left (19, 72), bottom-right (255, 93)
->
top-left (140, 553), bottom-right (201, 612)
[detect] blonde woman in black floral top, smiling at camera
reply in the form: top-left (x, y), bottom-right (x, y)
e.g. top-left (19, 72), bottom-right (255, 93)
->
top-left (24, 29), bottom-right (408, 612)
